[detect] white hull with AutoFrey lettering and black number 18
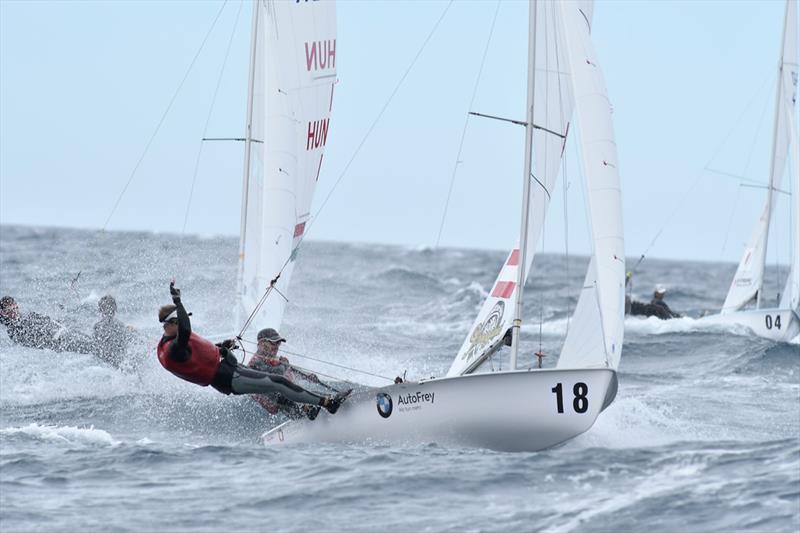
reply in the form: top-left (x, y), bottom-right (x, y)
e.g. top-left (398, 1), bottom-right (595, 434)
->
top-left (262, 369), bottom-right (617, 451)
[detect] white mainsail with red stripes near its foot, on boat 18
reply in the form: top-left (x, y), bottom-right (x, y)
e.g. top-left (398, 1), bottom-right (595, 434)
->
top-left (447, 1), bottom-right (580, 376)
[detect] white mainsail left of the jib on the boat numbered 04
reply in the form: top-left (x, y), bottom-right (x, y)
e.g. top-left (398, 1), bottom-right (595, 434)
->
top-left (720, 0), bottom-right (797, 314)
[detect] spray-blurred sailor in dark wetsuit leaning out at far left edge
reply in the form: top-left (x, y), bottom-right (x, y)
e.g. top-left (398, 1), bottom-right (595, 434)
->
top-left (0, 296), bottom-right (93, 354)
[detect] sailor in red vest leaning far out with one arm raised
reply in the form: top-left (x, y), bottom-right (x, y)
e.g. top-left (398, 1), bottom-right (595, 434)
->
top-left (157, 282), bottom-right (346, 413)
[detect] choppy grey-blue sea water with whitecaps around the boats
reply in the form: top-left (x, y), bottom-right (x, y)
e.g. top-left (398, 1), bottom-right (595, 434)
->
top-left (0, 222), bottom-right (800, 533)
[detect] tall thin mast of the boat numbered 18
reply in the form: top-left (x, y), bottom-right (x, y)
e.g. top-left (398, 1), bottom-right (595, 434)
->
top-left (510, 0), bottom-right (538, 370)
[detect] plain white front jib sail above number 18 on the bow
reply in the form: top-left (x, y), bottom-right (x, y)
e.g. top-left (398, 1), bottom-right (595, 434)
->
top-left (558, 2), bottom-right (625, 370)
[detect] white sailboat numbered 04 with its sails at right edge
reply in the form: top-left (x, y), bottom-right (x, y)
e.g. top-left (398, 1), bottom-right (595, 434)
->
top-left (701, 0), bottom-right (800, 341)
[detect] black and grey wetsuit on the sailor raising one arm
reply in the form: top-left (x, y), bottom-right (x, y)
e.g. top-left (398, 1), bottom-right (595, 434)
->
top-left (160, 299), bottom-right (325, 405)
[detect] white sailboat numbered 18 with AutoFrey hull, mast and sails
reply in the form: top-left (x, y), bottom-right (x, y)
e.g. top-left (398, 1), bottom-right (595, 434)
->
top-left (260, 0), bottom-right (625, 451)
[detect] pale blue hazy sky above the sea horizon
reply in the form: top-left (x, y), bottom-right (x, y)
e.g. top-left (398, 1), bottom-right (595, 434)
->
top-left (0, 0), bottom-right (792, 263)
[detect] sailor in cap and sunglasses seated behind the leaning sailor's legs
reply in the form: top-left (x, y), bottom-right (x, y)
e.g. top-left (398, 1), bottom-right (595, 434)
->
top-left (247, 328), bottom-right (320, 420)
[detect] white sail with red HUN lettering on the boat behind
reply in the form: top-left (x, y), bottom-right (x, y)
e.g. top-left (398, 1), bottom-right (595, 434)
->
top-left (236, 0), bottom-right (336, 338)
